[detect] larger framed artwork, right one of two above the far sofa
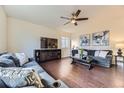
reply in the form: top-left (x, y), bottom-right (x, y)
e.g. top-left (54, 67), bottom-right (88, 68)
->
top-left (92, 31), bottom-right (110, 46)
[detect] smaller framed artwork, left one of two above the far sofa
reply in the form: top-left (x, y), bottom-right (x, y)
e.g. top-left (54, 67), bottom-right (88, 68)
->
top-left (80, 34), bottom-right (90, 47)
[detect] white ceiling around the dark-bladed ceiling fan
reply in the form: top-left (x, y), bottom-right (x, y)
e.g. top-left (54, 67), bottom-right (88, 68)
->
top-left (4, 5), bottom-right (124, 32)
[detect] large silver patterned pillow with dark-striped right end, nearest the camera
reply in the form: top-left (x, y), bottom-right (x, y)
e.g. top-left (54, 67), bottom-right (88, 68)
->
top-left (0, 67), bottom-right (44, 88)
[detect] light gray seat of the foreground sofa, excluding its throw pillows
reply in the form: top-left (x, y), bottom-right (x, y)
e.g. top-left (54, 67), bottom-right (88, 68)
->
top-left (0, 54), bottom-right (68, 88)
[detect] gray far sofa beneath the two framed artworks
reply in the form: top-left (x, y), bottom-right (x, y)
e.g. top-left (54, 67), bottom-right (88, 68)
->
top-left (72, 49), bottom-right (113, 68)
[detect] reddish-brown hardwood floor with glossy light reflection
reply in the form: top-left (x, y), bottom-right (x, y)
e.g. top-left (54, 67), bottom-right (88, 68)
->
top-left (41, 58), bottom-right (124, 88)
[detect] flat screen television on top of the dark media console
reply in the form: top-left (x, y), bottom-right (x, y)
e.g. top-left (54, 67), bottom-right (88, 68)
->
top-left (40, 37), bottom-right (58, 48)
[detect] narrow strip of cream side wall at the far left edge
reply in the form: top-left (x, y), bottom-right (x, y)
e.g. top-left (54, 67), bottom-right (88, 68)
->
top-left (0, 6), bottom-right (7, 52)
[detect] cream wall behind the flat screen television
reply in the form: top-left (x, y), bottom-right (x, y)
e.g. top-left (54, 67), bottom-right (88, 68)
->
top-left (8, 17), bottom-right (70, 57)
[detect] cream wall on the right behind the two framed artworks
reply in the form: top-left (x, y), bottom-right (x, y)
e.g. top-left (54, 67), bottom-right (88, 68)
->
top-left (71, 6), bottom-right (124, 52)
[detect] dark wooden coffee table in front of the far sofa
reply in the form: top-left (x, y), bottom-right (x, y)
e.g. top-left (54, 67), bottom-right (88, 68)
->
top-left (71, 56), bottom-right (93, 70)
